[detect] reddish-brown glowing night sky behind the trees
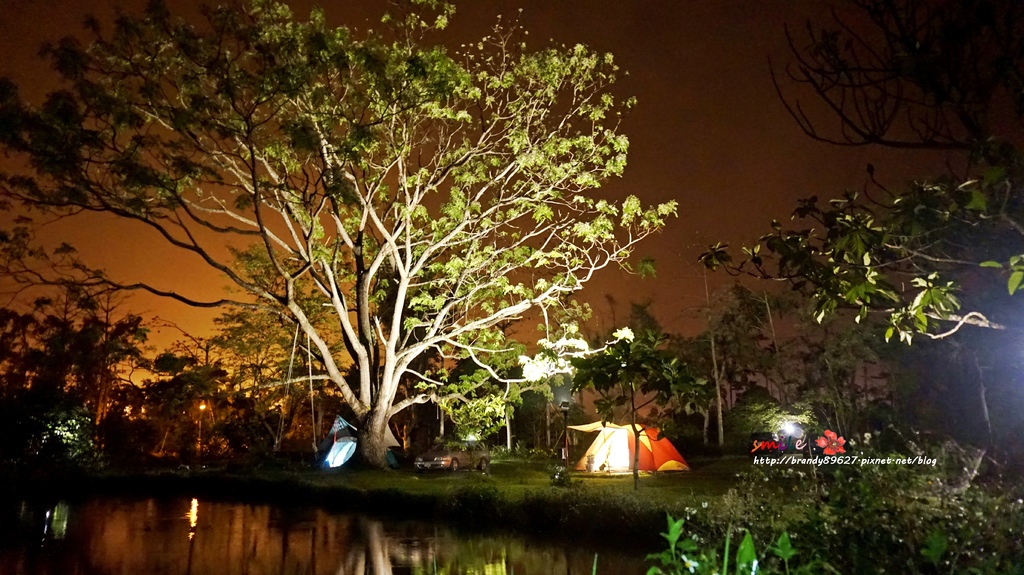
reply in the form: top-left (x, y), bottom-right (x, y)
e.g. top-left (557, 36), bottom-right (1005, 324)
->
top-left (0, 0), bottom-right (940, 344)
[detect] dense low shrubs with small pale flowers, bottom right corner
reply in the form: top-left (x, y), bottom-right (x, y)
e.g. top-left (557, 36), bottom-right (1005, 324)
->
top-left (687, 433), bottom-right (1024, 574)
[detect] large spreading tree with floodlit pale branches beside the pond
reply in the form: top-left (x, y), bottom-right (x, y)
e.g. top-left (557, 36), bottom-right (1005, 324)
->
top-left (0, 0), bottom-right (675, 465)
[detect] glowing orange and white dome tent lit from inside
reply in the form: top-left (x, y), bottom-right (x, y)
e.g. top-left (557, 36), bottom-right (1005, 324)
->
top-left (569, 422), bottom-right (690, 473)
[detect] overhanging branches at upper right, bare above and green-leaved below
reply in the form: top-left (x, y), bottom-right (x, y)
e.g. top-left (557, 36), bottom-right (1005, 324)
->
top-left (702, 0), bottom-right (1024, 342)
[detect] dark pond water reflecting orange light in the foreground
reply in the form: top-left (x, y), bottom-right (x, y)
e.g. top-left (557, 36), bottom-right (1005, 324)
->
top-left (0, 498), bottom-right (645, 575)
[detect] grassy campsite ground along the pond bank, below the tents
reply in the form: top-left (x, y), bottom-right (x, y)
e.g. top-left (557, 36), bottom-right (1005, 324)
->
top-left (0, 456), bottom-right (753, 510)
